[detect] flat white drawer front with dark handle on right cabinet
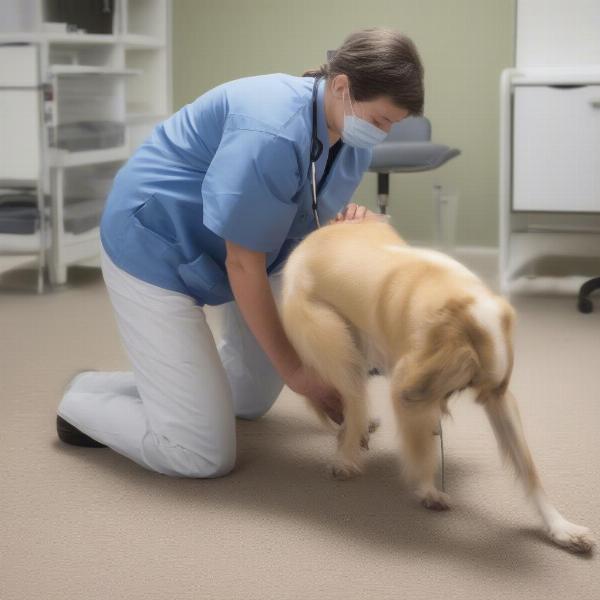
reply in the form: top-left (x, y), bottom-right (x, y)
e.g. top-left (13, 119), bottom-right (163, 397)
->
top-left (513, 85), bottom-right (600, 212)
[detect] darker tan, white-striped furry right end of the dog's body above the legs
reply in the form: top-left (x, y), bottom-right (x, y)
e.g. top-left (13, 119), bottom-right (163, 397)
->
top-left (395, 297), bottom-right (514, 412)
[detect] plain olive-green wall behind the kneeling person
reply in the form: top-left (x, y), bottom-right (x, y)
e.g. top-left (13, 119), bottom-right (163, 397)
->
top-left (173, 0), bottom-right (515, 246)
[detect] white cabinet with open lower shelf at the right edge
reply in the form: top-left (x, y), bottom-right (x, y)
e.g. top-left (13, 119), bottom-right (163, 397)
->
top-left (499, 66), bottom-right (600, 294)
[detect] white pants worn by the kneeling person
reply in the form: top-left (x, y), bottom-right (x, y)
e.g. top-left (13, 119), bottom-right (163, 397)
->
top-left (58, 245), bottom-right (283, 477)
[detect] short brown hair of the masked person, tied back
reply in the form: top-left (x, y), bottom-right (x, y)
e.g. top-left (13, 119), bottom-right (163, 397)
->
top-left (304, 27), bottom-right (424, 115)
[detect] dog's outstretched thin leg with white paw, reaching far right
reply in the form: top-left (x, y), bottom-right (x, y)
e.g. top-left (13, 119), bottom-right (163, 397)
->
top-left (484, 391), bottom-right (594, 552)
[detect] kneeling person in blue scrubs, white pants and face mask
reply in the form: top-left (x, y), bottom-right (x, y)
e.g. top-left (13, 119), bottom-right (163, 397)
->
top-left (57, 29), bottom-right (423, 477)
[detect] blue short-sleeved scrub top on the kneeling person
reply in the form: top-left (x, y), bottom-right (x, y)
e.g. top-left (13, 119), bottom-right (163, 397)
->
top-left (100, 74), bottom-right (371, 305)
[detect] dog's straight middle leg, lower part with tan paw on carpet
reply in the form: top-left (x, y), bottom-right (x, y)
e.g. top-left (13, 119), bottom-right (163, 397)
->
top-left (394, 400), bottom-right (450, 510)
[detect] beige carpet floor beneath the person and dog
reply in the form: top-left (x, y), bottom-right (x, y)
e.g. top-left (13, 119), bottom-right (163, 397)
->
top-left (0, 258), bottom-right (600, 600)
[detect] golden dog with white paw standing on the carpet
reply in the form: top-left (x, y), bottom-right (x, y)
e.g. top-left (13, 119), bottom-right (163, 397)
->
top-left (281, 221), bottom-right (594, 552)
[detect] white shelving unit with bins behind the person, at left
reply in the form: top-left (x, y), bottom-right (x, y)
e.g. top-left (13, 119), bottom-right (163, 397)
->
top-left (0, 0), bottom-right (172, 290)
